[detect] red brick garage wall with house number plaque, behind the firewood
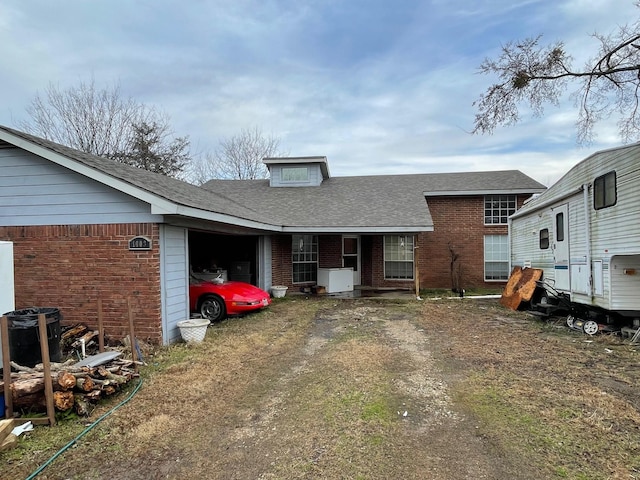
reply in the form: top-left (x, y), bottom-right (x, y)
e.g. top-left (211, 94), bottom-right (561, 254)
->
top-left (0, 224), bottom-right (162, 343)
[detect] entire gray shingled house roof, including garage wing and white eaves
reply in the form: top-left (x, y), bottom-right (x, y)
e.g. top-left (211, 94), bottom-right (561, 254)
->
top-left (0, 126), bottom-right (545, 233)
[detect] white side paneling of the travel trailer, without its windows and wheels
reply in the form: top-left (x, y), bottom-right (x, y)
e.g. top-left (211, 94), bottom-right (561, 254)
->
top-left (511, 144), bottom-right (640, 311)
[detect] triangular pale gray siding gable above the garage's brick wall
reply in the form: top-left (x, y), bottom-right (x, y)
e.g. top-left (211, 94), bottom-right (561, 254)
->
top-left (0, 148), bottom-right (162, 226)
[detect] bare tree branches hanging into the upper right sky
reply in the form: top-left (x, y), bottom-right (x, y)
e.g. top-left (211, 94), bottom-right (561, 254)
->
top-left (473, 2), bottom-right (640, 144)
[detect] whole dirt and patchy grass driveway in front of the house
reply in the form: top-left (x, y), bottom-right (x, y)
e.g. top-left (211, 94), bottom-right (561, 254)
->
top-left (0, 297), bottom-right (640, 480)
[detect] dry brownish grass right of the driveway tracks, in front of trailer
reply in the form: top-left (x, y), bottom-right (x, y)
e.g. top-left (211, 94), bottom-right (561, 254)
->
top-left (422, 304), bottom-right (640, 479)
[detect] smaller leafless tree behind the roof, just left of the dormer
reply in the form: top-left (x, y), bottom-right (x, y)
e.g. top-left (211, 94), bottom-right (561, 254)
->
top-left (190, 127), bottom-right (284, 185)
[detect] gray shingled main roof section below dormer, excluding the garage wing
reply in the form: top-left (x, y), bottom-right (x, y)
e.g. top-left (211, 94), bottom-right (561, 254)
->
top-left (204, 170), bottom-right (545, 231)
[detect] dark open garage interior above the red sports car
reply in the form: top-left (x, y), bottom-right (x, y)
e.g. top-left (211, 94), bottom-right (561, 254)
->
top-left (189, 230), bottom-right (259, 285)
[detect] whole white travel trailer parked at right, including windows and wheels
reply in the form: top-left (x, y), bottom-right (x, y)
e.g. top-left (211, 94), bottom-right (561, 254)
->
top-left (509, 143), bottom-right (640, 334)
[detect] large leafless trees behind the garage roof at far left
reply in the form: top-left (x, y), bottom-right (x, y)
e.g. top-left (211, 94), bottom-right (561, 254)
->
top-left (19, 80), bottom-right (189, 176)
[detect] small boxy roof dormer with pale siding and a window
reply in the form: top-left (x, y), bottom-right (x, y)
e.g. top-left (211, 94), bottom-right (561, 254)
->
top-left (262, 157), bottom-right (329, 187)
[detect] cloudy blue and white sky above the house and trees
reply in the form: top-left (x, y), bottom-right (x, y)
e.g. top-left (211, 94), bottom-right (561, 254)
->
top-left (0, 0), bottom-right (640, 185)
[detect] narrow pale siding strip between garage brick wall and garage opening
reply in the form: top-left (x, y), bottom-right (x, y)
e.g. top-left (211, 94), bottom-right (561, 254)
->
top-left (160, 225), bottom-right (189, 345)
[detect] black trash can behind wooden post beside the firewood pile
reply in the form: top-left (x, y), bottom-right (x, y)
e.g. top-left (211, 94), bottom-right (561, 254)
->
top-left (4, 307), bottom-right (62, 367)
